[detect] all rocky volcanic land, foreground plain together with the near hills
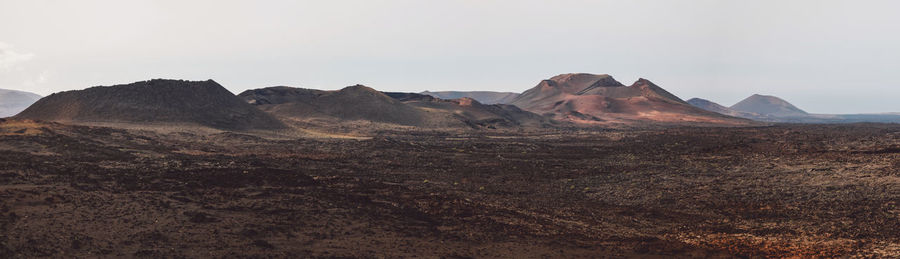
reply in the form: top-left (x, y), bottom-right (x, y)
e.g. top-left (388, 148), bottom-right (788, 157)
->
top-left (0, 74), bottom-right (900, 258)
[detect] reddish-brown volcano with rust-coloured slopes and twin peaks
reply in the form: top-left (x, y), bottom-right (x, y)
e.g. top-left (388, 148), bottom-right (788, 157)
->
top-left (510, 74), bottom-right (749, 124)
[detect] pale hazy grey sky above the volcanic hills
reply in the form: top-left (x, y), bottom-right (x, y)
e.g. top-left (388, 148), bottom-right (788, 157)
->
top-left (0, 0), bottom-right (900, 113)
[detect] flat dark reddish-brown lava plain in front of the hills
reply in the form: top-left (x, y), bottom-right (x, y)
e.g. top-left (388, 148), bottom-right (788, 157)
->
top-left (0, 121), bottom-right (900, 258)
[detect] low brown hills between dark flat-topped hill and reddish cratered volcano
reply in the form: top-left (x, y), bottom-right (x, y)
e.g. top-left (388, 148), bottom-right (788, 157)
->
top-left (239, 85), bottom-right (545, 128)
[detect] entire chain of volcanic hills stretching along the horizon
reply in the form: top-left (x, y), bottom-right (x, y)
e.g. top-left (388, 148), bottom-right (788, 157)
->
top-left (12, 76), bottom-right (900, 130)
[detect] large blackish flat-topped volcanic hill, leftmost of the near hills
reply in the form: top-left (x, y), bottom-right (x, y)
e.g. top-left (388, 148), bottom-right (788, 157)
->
top-left (16, 79), bottom-right (286, 130)
